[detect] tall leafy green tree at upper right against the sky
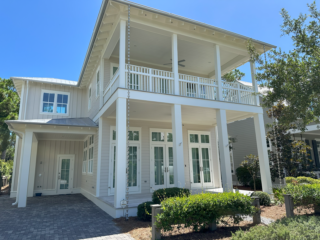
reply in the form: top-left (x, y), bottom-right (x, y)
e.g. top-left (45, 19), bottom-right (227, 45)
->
top-left (248, 2), bottom-right (320, 130)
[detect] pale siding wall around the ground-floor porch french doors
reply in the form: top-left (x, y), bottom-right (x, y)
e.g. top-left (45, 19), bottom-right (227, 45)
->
top-left (100, 118), bottom-right (221, 196)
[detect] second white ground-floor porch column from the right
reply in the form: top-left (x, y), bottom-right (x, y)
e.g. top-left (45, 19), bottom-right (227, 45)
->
top-left (216, 109), bottom-right (233, 192)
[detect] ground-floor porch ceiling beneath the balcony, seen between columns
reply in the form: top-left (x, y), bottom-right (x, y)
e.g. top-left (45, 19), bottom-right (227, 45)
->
top-left (104, 100), bottom-right (253, 126)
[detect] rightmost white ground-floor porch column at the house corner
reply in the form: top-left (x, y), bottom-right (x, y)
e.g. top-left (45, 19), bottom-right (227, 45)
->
top-left (253, 113), bottom-right (272, 194)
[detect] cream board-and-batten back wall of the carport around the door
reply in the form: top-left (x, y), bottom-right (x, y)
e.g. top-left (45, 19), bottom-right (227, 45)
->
top-left (34, 140), bottom-right (83, 192)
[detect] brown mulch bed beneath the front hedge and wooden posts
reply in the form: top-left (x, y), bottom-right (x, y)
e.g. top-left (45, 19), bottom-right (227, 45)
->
top-left (114, 217), bottom-right (264, 240)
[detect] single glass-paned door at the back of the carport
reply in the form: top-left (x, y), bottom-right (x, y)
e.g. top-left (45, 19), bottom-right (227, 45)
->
top-left (57, 155), bottom-right (74, 194)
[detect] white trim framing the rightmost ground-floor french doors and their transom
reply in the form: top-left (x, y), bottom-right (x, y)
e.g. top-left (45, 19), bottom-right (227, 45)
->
top-left (187, 130), bottom-right (215, 189)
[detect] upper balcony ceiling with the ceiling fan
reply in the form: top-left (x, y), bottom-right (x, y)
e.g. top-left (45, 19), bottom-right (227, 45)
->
top-left (112, 24), bottom-right (248, 77)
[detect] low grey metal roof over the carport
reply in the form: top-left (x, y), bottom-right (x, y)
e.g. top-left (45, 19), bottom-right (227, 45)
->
top-left (5, 118), bottom-right (98, 128)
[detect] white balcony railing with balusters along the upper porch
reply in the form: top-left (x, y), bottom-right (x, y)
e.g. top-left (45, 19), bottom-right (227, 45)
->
top-left (104, 65), bottom-right (256, 105)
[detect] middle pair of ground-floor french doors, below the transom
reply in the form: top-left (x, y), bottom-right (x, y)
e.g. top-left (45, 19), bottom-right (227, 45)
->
top-left (151, 144), bottom-right (174, 190)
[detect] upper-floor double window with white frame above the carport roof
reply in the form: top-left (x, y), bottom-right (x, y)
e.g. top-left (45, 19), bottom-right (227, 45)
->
top-left (40, 90), bottom-right (70, 114)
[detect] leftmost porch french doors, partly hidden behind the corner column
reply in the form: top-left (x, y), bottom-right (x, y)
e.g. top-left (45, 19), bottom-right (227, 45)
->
top-left (110, 144), bottom-right (140, 194)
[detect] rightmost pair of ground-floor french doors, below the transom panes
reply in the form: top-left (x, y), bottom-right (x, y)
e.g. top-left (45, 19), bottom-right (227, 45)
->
top-left (189, 145), bottom-right (213, 188)
